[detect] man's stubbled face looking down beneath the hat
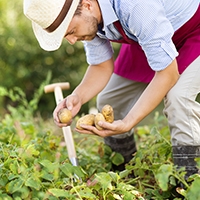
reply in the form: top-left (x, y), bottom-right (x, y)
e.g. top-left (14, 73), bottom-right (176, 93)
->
top-left (64, 13), bottom-right (98, 44)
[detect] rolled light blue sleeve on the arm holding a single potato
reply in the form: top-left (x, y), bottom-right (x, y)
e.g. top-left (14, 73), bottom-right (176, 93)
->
top-left (83, 36), bottom-right (113, 65)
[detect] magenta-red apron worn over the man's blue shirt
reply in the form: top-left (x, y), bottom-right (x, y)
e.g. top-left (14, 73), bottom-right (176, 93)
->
top-left (111, 6), bottom-right (200, 83)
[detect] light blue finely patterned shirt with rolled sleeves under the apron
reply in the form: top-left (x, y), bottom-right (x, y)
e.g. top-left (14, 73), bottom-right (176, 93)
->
top-left (83, 0), bottom-right (200, 71)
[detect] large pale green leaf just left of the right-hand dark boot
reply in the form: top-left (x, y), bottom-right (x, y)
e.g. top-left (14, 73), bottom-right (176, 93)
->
top-left (155, 164), bottom-right (173, 191)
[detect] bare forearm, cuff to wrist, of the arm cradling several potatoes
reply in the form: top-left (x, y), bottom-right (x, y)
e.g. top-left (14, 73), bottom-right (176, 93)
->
top-left (123, 58), bottom-right (179, 128)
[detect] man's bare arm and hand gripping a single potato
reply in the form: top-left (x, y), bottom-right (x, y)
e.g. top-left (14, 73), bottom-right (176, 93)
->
top-left (53, 58), bottom-right (114, 127)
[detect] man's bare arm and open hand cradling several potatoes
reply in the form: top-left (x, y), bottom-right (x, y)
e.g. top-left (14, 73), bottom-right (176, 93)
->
top-left (79, 57), bottom-right (179, 137)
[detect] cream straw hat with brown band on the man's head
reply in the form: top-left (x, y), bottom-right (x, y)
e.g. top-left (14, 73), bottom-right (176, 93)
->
top-left (24, 0), bottom-right (80, 51)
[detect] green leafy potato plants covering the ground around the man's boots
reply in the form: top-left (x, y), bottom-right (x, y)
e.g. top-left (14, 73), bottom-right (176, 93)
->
top-left (0, 81), bottom-right (200, 200)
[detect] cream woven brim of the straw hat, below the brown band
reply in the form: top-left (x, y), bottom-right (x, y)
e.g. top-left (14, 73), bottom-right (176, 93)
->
top-left (32, 0), bottom-right (79, 51)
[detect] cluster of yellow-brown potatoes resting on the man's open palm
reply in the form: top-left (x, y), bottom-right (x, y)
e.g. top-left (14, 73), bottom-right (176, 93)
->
top-left (76, 104), bottom-right (114, 130)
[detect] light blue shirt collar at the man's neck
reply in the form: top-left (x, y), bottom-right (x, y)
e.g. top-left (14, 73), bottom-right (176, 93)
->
top-left (98, 0), bottom-right (118, 31)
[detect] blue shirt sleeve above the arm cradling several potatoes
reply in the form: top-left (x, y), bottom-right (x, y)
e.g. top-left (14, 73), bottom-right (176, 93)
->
top-left (121, 0), bottom-right (178, 71)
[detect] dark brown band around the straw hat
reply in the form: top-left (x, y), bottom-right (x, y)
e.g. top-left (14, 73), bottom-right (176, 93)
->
top-left (45, 0), bottom-right (73, 33)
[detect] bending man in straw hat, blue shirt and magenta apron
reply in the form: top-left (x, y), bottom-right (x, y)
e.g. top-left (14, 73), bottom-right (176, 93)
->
top-left (24, 0), bottom-right (200, 176)
